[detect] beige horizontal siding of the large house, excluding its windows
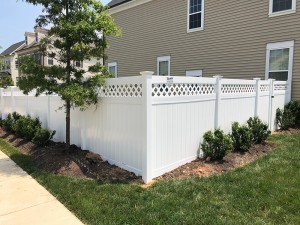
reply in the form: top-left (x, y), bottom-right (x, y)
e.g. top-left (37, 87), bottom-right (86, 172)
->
top-left (107, 0), bottom-right (300, 99)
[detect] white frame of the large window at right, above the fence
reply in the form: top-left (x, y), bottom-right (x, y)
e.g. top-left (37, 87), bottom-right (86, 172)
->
top-left (265, 41), bottom-right (294, 81)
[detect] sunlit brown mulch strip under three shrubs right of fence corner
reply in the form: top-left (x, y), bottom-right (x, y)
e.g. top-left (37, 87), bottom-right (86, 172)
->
top-left (157, 143), bottom-right (275, 180)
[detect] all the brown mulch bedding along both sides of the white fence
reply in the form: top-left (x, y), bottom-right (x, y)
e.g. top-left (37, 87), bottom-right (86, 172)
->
top-left (0, 128), bottom-right (299, 184)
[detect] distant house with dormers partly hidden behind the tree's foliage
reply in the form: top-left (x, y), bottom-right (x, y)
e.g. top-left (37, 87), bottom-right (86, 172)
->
top-left (16, 28), bottom-right (102, 77)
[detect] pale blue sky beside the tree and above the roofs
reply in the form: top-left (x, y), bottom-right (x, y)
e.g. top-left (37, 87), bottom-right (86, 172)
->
top-left (0, 0), bottom-right (110, 53)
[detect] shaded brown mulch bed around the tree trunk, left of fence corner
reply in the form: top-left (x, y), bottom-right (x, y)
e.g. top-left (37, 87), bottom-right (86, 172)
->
top-left (0, 129), bottom-right (143, 184)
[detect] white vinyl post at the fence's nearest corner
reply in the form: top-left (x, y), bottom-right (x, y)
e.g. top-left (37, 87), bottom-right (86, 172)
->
top-left (140, 71), bottom-right (154, 183)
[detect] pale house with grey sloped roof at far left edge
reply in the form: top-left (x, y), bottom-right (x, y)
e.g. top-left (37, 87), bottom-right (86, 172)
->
top-left (0, 41), bottom-right (25, 84)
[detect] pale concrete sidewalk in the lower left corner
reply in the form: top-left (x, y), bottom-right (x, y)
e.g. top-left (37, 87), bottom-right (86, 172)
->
top-left (0, 151), bottom-right (82, 225)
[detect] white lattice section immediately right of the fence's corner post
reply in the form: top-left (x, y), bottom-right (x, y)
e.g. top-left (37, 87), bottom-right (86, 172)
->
top-left (152, 83), bottom-right (215, 97)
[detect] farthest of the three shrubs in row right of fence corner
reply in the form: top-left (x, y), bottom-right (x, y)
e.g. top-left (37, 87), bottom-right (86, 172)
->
top-left (247, 117), bottom-right (271, 144)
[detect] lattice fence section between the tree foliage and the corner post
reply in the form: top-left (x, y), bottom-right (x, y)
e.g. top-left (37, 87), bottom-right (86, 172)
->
top-left (101, 84), bottom-right (142, 98)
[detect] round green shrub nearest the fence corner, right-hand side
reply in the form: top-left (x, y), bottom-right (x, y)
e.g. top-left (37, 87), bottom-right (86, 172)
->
top-left (201, 129), bottom-right (232, 160)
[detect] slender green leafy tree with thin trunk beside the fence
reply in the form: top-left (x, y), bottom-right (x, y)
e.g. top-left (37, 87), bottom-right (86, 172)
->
top-left (17, 0), bottom-right (121, 148)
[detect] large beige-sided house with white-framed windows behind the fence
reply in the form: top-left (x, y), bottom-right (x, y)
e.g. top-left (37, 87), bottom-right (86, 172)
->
top-left (107, 0), bottom-right (300, 99)
